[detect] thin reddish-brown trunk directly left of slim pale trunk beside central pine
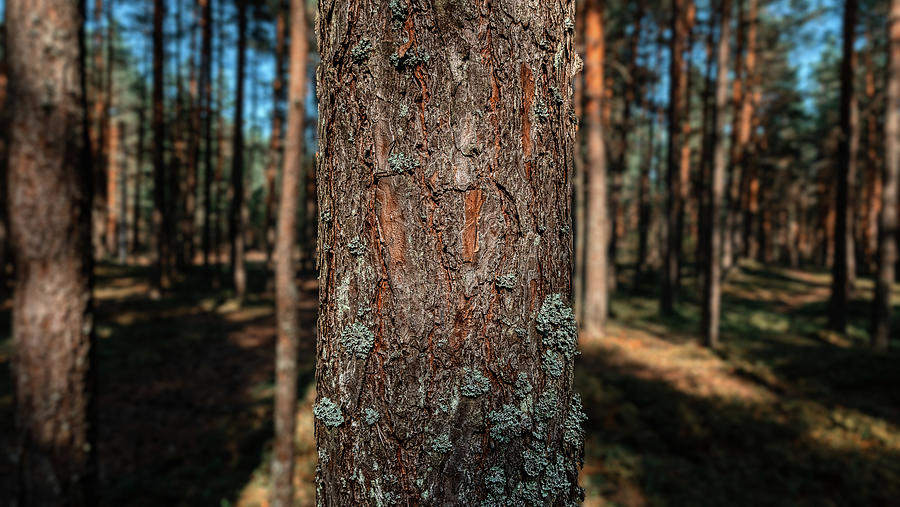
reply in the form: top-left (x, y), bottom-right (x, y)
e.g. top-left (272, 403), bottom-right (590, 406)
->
top-left (265, 0), bottom-right (286, 286)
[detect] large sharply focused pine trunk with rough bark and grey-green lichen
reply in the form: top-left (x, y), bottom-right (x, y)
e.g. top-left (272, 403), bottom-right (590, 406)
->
top-left (314, 0), bottom-right (583, 505)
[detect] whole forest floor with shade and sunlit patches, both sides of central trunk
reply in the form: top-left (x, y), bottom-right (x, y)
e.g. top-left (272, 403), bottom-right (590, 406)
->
top-left (0, 264), bottom-right (900, 507)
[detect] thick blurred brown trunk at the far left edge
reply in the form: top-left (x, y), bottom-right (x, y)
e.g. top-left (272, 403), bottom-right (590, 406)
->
top-left (6, 0), bottom-right (97, 506)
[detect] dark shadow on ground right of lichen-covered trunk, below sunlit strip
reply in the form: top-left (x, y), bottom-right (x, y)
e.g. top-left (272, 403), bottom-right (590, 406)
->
top-left (577, 347), bottom-right (900, 506)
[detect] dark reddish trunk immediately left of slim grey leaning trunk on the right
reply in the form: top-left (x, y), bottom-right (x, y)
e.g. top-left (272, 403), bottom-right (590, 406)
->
top-left (659, 0), bottom-right (690, 315)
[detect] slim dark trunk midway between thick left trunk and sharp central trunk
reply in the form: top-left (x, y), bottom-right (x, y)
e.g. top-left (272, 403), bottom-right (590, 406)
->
top-left (197, 0), bottom-right (213, 271)
